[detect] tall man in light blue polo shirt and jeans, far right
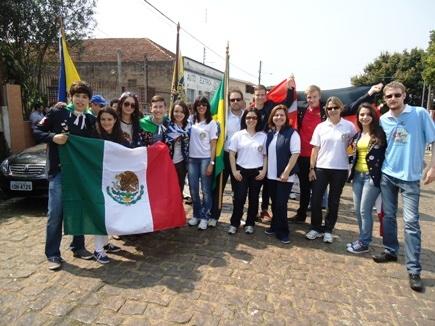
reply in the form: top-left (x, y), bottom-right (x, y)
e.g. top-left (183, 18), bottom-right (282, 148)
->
top-left (373, 81), bottom-right (435, 292)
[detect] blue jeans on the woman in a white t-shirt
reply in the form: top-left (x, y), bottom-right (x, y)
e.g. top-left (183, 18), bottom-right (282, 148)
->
top-left (188, 158), bottom-right (213, 220)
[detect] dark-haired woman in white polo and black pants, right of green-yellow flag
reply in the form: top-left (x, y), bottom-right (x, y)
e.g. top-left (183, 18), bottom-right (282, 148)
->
top-left (228, 108), bottom-right (267, 234)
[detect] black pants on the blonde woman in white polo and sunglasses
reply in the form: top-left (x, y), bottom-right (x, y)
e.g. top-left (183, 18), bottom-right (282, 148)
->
top-left (311, 168), bottom-right (348, 232)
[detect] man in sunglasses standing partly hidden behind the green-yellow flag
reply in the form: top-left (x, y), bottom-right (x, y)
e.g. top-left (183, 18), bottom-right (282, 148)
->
top-left (208, 89), bottom-right (245, 227)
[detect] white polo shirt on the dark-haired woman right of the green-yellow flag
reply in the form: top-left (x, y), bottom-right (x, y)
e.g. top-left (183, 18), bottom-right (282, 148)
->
top-left (229, 129), bottom-right (267, 169)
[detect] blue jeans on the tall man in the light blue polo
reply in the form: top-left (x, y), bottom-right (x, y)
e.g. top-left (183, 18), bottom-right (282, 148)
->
top-left (381, 173), bottom-right (421, 274)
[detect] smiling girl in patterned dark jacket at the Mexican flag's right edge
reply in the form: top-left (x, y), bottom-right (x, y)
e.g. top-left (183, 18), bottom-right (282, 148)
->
top-left (164, 100), bottom-right (190, 195)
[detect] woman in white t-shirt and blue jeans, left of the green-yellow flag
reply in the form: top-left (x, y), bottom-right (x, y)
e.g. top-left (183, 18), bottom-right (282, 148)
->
top-left (188, 97), bottom-right (218, 230)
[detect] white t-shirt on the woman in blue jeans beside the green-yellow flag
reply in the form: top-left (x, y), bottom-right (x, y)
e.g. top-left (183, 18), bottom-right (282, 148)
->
top-left (189, 120), bottom-right (218, 158)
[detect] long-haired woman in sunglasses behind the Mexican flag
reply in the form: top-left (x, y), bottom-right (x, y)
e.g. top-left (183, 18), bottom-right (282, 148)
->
top-left (117, 92), bottom-right (144, 148)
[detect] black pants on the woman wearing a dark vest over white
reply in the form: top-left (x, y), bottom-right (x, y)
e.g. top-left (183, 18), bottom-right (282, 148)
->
top-left (267, 180), bottom-right (293, 238)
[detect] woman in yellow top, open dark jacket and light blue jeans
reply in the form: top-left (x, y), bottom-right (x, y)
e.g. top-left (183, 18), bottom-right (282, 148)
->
top-left (347, 103), bottom-right (386, 254)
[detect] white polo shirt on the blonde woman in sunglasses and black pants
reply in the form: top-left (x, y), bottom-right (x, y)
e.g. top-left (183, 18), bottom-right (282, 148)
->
top-left (310, 118), bottom-right (356, 170)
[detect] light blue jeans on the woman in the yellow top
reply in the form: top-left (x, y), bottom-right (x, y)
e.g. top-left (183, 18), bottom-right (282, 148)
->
top-left (352, 171), bottom-right (381, 246)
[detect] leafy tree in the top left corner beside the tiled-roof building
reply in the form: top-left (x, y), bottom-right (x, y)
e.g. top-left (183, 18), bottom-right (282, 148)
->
top-left (0, 0), bottom-right (96, 114)
